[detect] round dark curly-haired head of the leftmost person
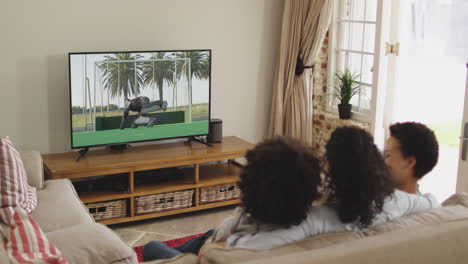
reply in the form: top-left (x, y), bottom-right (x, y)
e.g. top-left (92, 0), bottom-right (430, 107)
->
top-left (239, 137), bottom-right (321, 227)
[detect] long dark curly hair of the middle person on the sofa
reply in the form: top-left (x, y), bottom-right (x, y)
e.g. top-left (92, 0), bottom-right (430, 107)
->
top-left (326, 127), bottom-right (394, 226)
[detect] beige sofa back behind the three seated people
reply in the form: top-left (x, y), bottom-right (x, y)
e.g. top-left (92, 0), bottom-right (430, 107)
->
top-left (146, 193), bottom-right (468, 264)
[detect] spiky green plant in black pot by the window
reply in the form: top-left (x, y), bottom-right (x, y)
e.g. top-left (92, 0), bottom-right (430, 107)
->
top-left (331, 69), bottom-right (361, 119)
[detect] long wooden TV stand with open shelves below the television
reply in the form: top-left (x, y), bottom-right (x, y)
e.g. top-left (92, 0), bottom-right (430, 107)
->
top-left (43, 137), bottom-right (253, 224)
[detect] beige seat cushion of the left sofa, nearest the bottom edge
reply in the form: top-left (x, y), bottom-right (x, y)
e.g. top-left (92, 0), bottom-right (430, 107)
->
top-left (46, 223), bottom-right (138, 264)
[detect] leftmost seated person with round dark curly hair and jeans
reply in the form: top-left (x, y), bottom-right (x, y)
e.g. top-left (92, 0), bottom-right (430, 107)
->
top-left (143, 137), bottom-right (322, 261)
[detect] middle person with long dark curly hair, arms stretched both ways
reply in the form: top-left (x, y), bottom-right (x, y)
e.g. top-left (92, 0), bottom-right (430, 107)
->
top-left (229, 127), bottom-right (439, 249)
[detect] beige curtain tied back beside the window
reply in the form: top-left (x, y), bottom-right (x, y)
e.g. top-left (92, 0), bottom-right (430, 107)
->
top-left (270, 0), bottom-right (334, 144)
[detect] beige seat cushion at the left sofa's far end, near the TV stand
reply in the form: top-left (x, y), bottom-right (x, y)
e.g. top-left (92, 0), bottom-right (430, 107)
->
top-left (31, 179), bottom-right (95, 233)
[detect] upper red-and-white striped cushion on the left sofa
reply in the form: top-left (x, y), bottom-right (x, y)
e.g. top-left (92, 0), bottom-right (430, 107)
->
top-left (0, 137), bottom-right (37, 213)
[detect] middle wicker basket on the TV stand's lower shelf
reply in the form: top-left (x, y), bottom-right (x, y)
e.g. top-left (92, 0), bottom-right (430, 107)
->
top-left (135, 190), bottom-right (194, 214)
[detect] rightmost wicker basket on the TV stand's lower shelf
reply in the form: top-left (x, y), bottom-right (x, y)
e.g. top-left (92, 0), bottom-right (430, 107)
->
top-left (200, 182), bottom-right (240, 204)
